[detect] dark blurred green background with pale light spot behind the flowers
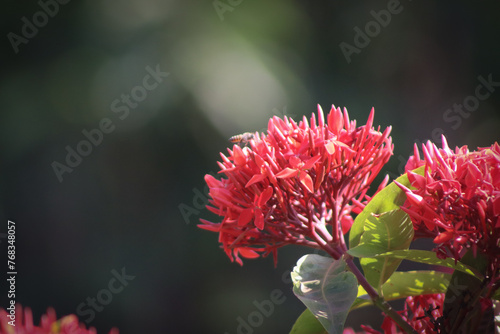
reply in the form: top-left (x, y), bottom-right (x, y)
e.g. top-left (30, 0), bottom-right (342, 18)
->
top-left (0, 0), bottom-right (500, 334)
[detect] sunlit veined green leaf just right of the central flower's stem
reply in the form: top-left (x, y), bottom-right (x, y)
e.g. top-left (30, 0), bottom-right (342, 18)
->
top-left (348, 209), bottom-right (413, 289)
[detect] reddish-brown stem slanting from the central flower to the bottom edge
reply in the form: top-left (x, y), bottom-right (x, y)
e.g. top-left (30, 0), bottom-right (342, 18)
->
top-left (344, 254), bottom-right (417, 334)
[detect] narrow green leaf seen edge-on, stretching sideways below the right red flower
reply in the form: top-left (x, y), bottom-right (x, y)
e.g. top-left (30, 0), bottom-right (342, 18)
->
top-left (365, 249), bottom-right (484, 280)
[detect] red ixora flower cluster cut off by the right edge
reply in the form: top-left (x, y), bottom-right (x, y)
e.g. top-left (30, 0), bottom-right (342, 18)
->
top-left (399, 137), bottom-right (500, 275)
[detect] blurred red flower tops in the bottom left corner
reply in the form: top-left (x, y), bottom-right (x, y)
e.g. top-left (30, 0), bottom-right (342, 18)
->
top-left (0, 305), bottom-right (119, 334)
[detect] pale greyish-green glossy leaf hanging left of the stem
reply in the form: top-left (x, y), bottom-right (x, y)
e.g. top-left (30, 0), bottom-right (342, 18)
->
top-left (291, 254), bottom-right (358, 334)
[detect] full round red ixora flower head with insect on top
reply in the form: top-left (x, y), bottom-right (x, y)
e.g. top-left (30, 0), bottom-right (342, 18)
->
top-left (199, 106), bottom-right (393, 264)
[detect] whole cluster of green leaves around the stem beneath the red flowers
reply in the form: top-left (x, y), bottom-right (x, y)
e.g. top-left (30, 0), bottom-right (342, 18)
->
top-left (291, 167), bottom-right (488, 334)
